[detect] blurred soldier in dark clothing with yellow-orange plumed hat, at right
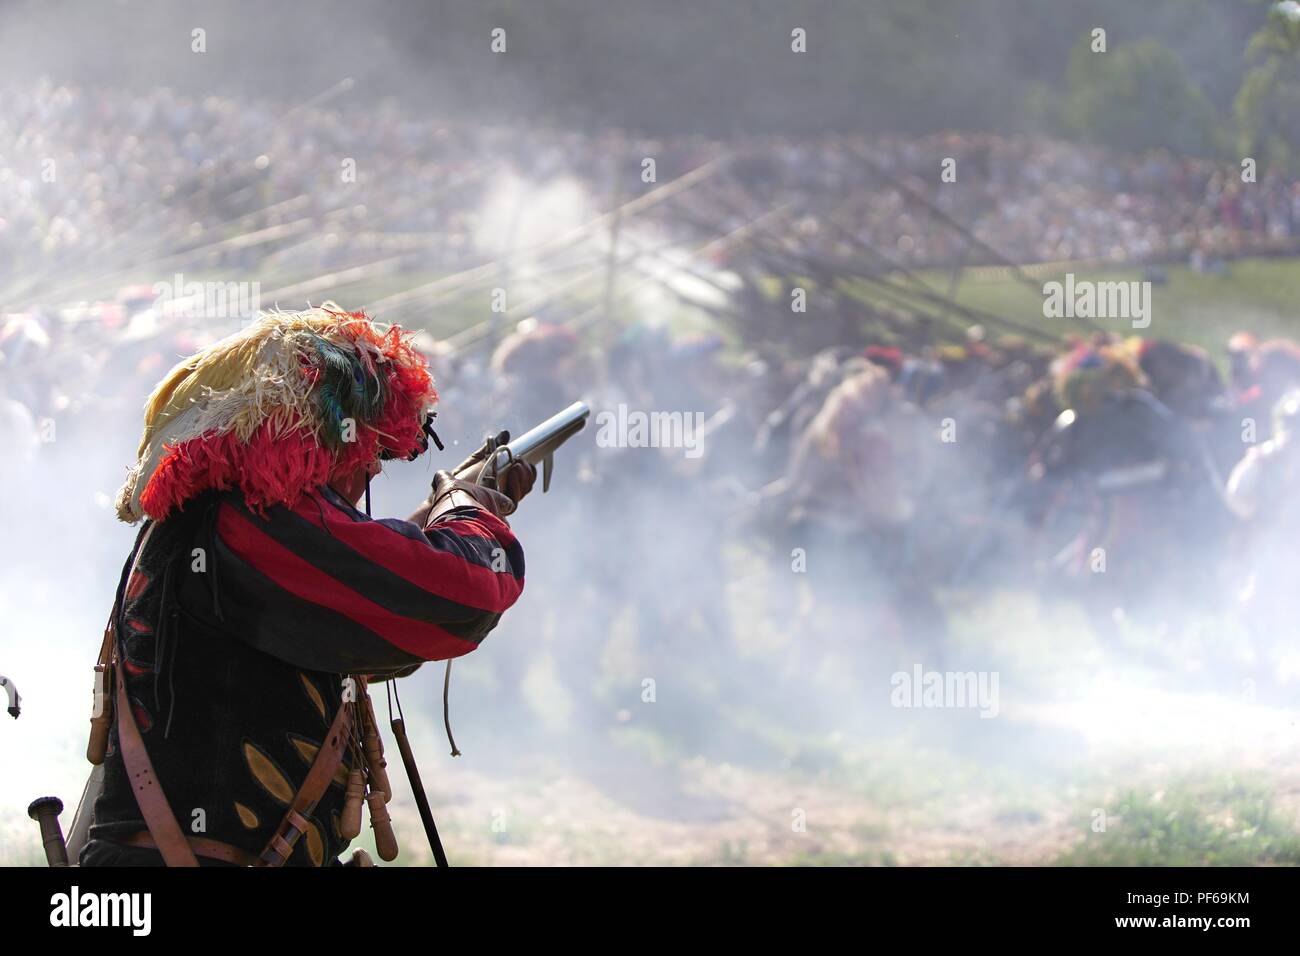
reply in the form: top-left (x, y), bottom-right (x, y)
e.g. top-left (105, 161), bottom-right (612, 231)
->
top-left (1024, 342), bottom-right (1227, 636)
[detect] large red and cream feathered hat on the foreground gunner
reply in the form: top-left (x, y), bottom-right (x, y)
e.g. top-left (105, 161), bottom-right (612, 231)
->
top-left (116, 304), bottom-right (438, 522)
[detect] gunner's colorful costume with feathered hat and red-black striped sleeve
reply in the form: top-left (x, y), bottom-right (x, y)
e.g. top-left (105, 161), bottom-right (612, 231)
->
top-left (81, 308), bottom-right (524, 866)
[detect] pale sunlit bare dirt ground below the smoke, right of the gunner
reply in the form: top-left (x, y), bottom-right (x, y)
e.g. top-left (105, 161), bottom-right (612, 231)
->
top-left (374, 680), bottom-right (1300, 865)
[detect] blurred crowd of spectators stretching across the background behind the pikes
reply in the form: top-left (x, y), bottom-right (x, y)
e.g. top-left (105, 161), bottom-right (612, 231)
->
top-left (0, 82), bottom-right (1300, 287)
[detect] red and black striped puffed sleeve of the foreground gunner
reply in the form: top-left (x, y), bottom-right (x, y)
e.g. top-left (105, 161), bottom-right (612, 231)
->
top-left (200, 488), bottom-right (524, 674)
